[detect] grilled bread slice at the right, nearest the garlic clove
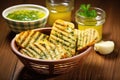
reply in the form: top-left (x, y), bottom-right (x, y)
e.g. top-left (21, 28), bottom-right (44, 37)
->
top-left (77, 28), bottom-right (99, 51)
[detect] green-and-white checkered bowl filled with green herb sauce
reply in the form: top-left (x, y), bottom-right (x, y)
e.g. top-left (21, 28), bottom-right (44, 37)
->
top-left (2, 4), bottom-right (49, 33)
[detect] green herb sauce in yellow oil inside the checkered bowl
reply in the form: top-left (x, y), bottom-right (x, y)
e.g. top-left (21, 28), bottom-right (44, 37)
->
top-left (7, 10), bottom-right (45, 21)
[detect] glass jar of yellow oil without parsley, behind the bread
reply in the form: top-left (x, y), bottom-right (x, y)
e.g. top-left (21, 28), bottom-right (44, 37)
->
top-left (46, 0), bottom-right (74, 26)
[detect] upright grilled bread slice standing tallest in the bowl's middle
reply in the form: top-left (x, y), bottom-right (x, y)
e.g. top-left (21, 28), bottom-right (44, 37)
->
top-left (49, 20), bottom-right (77, 57)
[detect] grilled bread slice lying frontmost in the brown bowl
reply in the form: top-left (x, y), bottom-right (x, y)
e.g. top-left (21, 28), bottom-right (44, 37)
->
top-left (20, 40), bottom-right (66, 60)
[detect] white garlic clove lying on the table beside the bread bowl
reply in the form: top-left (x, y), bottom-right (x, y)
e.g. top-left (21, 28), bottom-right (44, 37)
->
top-left (94, 41), bottom-right (114, 54)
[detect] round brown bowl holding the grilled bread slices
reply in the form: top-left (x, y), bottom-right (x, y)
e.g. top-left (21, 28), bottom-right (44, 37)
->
top-left (11, 28), bottom-right (93, 74)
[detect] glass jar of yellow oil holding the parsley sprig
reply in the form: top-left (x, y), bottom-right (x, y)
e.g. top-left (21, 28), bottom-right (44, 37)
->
top-left (75, 7), bottom-right (105, 40)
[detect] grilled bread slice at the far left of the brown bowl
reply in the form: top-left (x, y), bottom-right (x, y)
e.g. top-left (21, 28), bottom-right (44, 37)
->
top-left (15, 30), bottom-right (49, 48)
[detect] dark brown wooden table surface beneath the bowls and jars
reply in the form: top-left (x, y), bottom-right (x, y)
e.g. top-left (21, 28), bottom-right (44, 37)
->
top-left (0, 0), bottom-right (120, 80)
